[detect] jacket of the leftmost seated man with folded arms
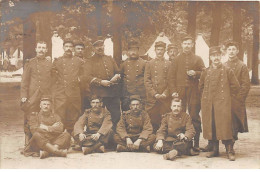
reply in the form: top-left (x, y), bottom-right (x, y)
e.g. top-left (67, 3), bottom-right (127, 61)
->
top-left (29, 112), bottom-right (64, 137)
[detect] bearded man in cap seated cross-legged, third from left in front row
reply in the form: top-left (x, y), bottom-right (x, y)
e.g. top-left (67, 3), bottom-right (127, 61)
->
top-left (114, 95), bottom-right (155, 152)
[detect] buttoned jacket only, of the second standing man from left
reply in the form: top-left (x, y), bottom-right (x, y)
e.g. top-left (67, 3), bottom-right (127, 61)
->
top-left (52, 55), bottom-right (84, 97)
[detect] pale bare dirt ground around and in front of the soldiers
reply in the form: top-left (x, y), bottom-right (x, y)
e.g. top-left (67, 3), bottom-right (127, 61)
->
top-left (0, 85), bottom-right (260, 168)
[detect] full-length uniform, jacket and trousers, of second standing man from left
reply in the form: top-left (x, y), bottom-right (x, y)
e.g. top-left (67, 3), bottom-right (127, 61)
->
top-left (52, 55), bottom-right (84, 133)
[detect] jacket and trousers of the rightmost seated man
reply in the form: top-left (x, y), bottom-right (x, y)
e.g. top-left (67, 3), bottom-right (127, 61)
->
top-left (155, 112), bottom-right (196, 154)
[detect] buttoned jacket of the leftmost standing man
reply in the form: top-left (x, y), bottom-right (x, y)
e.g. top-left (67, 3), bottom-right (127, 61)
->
top-left (21, 57), bottom-right (52, 99)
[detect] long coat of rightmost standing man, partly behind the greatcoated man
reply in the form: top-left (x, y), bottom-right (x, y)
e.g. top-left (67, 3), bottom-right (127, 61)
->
top-left (224, 58), bottom-right (250, 140)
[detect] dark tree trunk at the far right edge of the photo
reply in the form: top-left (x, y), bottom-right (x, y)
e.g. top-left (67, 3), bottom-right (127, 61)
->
top-left (251, 1), bottom-right (259, 85)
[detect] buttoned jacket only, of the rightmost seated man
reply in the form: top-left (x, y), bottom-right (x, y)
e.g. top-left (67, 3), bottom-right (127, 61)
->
top-left (156, 112), bottom-right (196, 141)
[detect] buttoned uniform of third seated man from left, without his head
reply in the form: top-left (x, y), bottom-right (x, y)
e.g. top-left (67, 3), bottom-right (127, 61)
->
top-left (114, 110), bottom-right (155, 148)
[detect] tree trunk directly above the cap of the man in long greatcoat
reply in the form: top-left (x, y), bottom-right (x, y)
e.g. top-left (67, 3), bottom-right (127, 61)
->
top-left (210, 2), bottom-right (221, 46)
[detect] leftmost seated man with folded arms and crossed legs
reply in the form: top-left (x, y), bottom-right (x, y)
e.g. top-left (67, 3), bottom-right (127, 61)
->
top-left (23, 97), bottom-right (70, 159)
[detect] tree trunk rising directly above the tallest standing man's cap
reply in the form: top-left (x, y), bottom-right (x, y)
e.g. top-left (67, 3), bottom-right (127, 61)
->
top-left (187, 1), bottom-right (197, 52)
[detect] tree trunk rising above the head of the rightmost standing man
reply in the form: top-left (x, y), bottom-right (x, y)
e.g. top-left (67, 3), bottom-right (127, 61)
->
top-left (233, 2), bottom-right (244, 61)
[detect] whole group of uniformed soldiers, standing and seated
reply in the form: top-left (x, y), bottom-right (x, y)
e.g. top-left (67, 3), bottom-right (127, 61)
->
top-left (21, 36), bottom-right (250, 161)
